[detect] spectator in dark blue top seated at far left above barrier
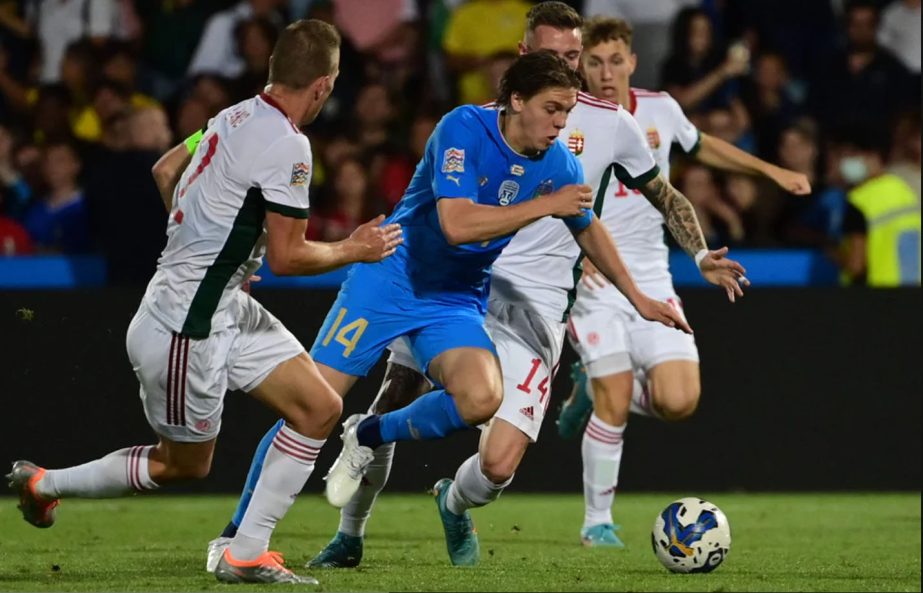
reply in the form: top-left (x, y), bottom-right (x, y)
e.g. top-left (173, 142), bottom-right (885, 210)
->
top-left (24, 141), bottom-right (91, 255)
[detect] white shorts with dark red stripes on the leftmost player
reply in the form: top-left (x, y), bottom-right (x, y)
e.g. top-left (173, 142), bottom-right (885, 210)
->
top-left (126, 292), bottom-right (305, 443)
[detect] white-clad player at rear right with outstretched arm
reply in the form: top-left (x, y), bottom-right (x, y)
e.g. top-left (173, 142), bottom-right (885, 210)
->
top-left (558, 17), bottom-right (811, 548)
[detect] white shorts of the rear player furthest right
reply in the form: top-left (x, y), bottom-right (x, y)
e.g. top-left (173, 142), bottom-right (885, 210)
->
top-left (567, 285), bottom-right (699, 378)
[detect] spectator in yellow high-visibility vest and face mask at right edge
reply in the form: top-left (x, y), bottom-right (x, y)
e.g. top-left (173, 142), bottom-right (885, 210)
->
top-left (840, 128), bottom-right (921, 288)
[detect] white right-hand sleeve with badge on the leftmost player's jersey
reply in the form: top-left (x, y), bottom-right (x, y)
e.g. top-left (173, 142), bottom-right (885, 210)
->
top-left (250, 134), bottom-right (311, 218)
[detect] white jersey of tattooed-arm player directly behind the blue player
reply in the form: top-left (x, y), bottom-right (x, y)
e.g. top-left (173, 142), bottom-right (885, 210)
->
top-left (491, 93), bottom-right (659, 321)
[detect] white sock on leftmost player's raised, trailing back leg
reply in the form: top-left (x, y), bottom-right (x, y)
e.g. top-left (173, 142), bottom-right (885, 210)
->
top-left (36, 445), bottom-right (157, 498)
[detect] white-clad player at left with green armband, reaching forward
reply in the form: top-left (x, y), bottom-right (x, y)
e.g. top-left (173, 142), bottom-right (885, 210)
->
top-left (7, 20), bottom-right (401, 584)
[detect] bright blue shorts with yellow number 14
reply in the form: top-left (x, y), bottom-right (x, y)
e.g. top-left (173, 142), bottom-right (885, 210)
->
top-left (311, 264), bottom-right (497, 376)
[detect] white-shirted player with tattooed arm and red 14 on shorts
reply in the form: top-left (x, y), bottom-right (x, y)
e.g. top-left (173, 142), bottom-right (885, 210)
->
top-left (226, 2), bottom-right (743, 567)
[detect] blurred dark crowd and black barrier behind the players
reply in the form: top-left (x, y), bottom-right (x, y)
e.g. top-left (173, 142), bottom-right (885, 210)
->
top-left (0, 0), bottom-right (923, 491)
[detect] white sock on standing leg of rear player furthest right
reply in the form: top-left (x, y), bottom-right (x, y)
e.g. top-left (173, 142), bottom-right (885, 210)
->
top-left (581, 413), bottom-right (627, 527)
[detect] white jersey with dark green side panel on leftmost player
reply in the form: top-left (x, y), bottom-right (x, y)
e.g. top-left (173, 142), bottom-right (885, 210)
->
top-left (144, 94), bottom-right (311, 339)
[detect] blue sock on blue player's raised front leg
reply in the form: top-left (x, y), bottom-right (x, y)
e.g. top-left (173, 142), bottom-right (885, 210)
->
top-left (357, 389), bottom-right (468, 449)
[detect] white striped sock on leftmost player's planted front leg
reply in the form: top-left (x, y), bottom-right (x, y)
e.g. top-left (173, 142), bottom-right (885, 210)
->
top-left (231, 424), bottom-right (325, 560)
